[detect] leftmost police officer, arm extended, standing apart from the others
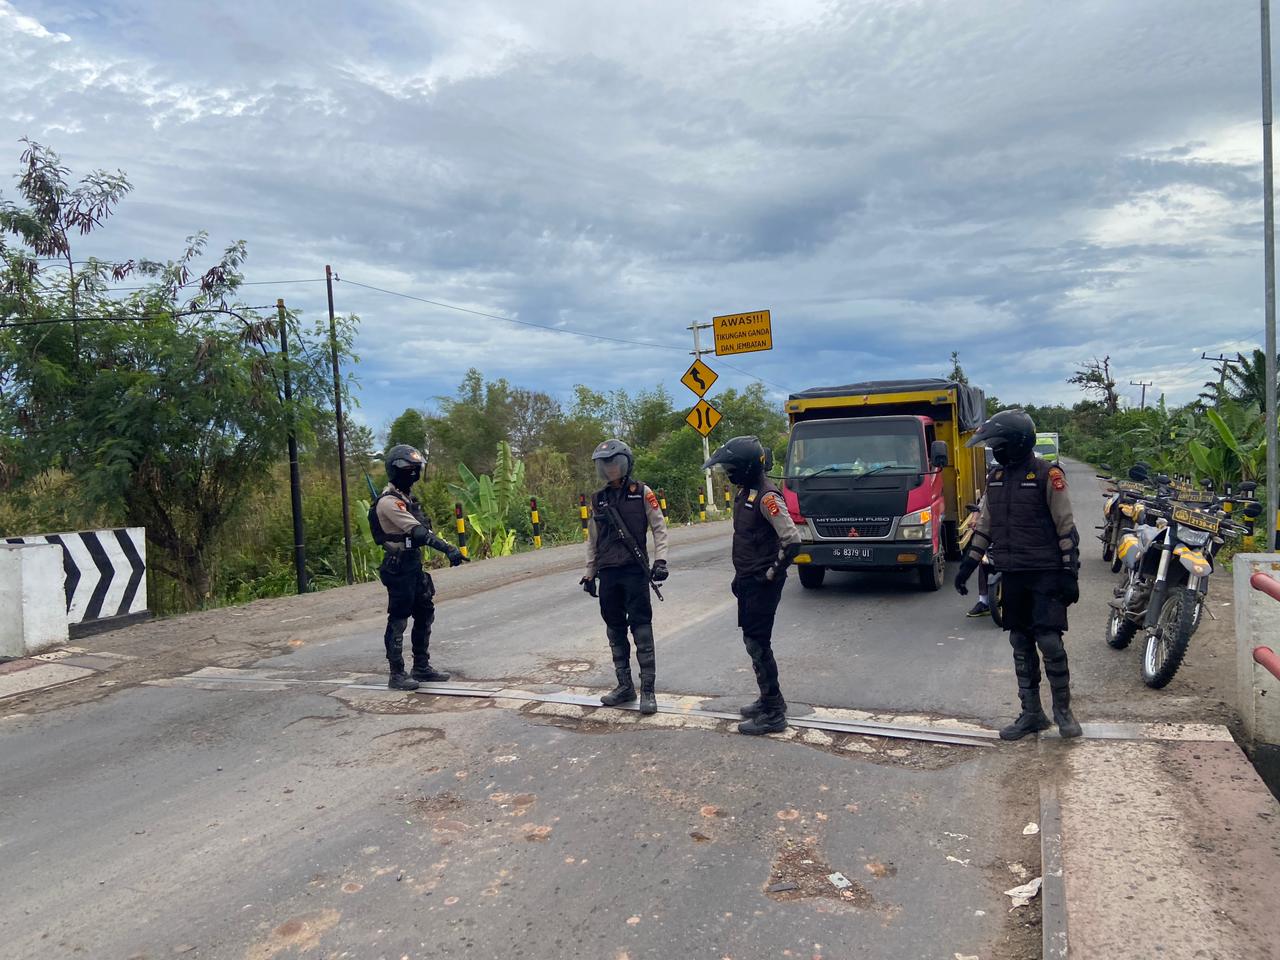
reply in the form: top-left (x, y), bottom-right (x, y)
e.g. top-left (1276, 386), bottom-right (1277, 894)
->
top-left (369, 443), bottom-right (466, 690)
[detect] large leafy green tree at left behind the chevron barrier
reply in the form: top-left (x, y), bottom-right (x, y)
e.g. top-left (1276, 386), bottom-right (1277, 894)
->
top-left (0, 143), bottom-right (351, 604)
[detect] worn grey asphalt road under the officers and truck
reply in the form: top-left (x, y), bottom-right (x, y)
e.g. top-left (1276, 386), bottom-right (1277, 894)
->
top-left (0, 460), bottom-right (1225, 960)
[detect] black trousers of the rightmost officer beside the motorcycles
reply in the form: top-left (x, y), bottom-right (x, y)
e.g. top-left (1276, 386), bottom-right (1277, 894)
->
top-left (1002, 571), bottom-right (1071, 705)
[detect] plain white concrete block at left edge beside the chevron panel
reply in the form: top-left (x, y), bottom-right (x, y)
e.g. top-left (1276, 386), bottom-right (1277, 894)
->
top-left (0, 544), bottom-right (67, 657)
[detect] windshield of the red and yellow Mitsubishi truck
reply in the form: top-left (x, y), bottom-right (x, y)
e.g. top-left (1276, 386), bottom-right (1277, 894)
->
top-left (787, 420), bottom-right (924, 477)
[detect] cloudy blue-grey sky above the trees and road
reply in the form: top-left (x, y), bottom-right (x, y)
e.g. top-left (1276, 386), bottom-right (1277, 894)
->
top-left (0, 0), bottom-right (1262, 428)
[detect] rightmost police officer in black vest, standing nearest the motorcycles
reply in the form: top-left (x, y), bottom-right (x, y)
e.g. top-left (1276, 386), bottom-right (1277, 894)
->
top-left (955, 410), bottom-right (1080, 740)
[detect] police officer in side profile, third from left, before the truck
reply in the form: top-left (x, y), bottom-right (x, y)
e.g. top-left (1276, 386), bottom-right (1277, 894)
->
top-left (703, 436), bottom-right (800, 736)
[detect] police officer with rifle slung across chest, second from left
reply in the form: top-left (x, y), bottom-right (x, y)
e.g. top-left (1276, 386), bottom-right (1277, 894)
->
top-left (579, 440), bottom-right (668, 713)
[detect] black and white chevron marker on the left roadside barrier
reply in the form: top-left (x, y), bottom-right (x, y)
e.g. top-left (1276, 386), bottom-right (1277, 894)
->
top-left (6, 526), bottom-right (147, 627)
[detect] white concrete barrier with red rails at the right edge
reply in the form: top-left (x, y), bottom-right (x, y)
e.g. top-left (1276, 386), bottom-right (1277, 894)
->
top-left (1231, 553), bottom-right (1280, 744)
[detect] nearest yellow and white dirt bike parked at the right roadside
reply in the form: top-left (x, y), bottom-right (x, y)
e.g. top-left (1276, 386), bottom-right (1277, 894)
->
top-left (1106, 475), bottom-right (1262, 690)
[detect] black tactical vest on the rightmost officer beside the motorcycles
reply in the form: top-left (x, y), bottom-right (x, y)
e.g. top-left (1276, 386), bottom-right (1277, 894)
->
top-left (987, 457), bottom-right (1062, 572)
